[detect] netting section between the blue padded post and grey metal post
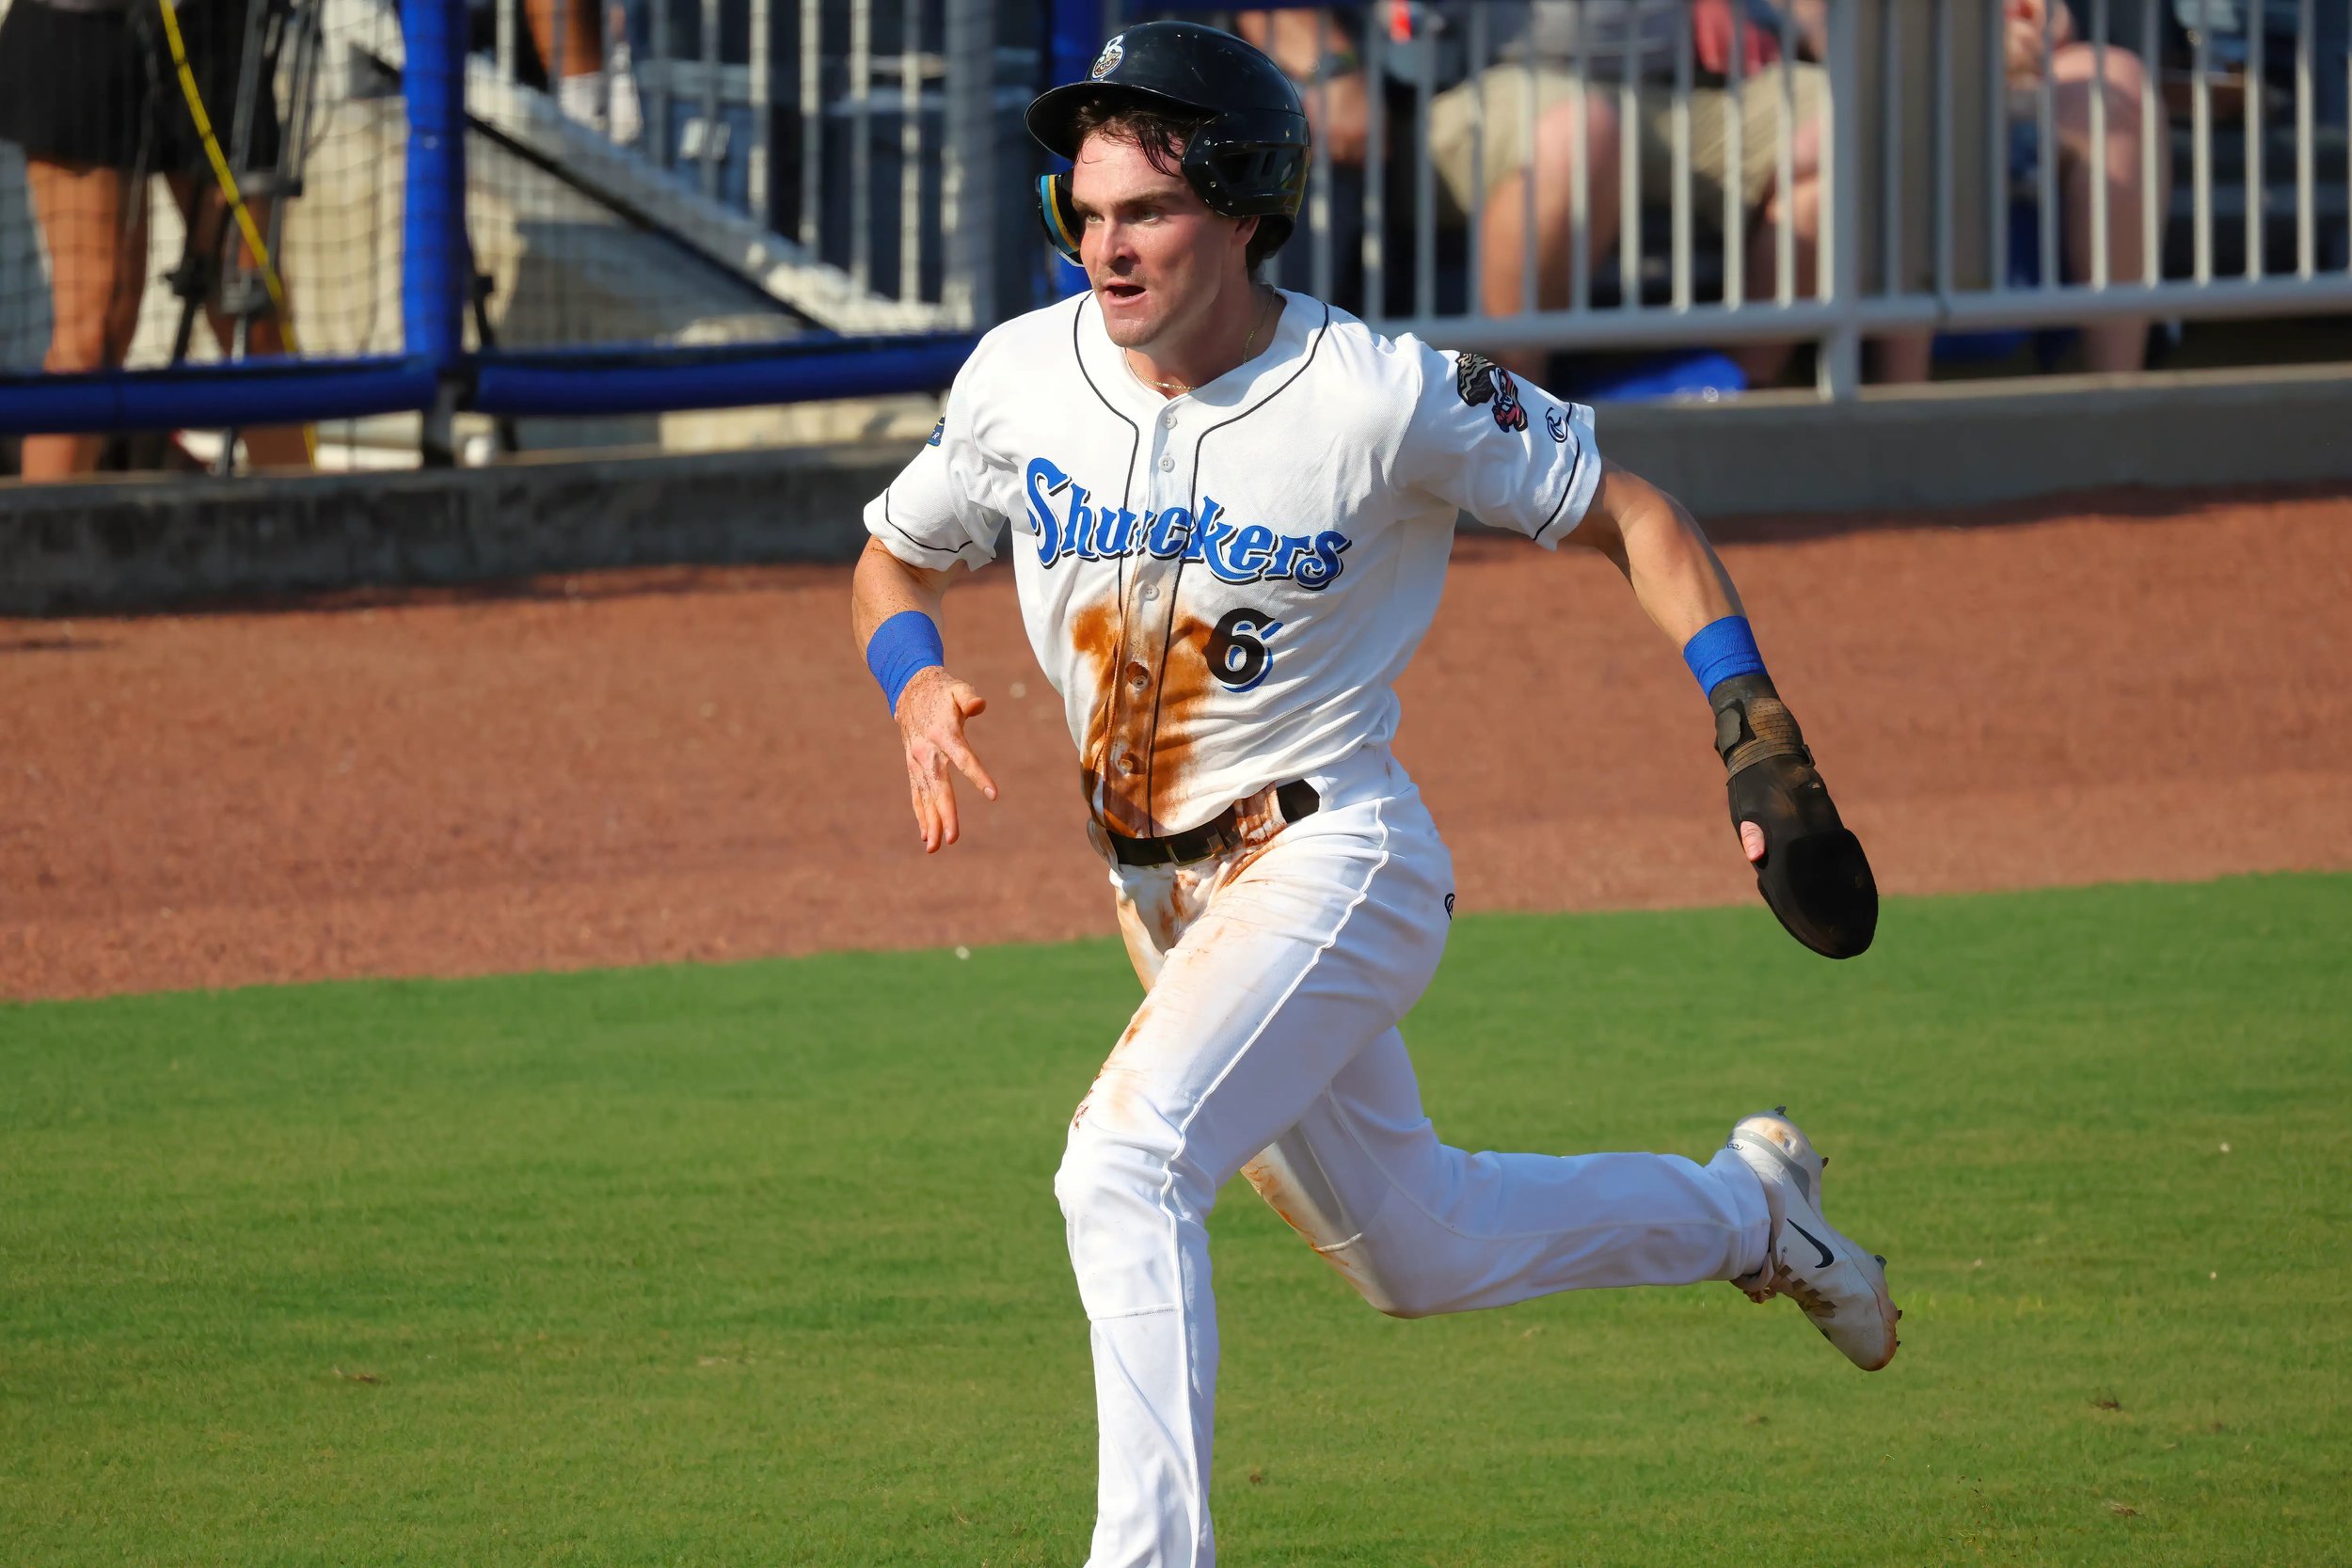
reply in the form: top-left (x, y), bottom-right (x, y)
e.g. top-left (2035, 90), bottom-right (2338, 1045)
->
top-left (449, 0), bottom-right (974, 348)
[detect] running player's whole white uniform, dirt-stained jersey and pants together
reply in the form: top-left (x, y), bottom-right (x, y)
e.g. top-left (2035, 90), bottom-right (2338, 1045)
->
top-left (866, 293), bottom-right (1772, 1568)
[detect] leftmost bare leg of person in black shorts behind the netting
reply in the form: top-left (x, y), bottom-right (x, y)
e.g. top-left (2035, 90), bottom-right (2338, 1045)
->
top-left (24, 157), bottom-right (146, 480)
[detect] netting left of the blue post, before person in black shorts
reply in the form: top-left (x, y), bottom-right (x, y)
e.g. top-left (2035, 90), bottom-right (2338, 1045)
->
top-left (0, 0), bottom-right (407, 372)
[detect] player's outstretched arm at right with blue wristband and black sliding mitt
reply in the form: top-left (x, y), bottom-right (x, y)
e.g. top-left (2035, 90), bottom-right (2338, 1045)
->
top-left (1566, 463), bottom-right (1880, 959)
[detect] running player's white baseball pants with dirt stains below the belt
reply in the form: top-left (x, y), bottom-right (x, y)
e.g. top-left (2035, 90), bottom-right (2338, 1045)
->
top-left (1054, 750), bottom-right (1769, 1568)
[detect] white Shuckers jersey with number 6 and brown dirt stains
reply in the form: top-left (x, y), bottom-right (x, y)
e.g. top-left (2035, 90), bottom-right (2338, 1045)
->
top-left (866, 293), bottom-right (1602, 837)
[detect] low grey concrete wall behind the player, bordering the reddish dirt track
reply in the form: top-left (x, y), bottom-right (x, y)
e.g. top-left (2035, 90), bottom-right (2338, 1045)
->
top-left (0, 367), bottom-right (2352, 616)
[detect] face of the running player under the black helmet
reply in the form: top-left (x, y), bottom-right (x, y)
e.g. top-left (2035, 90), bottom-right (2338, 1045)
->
top-left (1071, 134), bottom-right (1249, 348)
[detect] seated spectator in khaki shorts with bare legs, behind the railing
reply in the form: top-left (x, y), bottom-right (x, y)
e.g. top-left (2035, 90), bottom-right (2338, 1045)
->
top-left (1428, 0), bottom-right (1828, 386)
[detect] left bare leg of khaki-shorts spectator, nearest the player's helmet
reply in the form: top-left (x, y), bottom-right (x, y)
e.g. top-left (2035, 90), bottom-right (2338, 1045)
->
top-left (1477, 94), bottom-right (1618, 381)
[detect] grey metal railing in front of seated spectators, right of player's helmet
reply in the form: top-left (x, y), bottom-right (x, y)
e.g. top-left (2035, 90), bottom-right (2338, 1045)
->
top-left (1129, 0), bottom-right (2352, 397)
